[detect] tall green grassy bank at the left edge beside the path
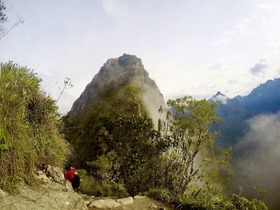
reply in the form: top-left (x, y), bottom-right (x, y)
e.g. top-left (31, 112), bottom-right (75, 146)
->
top-left (0, 62), bottom-right (70, 191)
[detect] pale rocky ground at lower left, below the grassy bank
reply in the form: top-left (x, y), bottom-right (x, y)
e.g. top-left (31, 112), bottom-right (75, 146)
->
top-left (0, 166), bottom-right (88, 210)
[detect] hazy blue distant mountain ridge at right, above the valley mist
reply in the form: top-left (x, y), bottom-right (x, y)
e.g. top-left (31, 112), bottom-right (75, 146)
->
top-left (209, 79), bottom-right (280, 146)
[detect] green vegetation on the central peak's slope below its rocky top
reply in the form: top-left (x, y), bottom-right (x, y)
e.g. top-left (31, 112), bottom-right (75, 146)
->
top-left (63, 82), bottom-right (147, 167)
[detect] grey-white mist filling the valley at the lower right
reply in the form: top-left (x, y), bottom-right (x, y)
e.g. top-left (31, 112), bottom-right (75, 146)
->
top-left (233, 113), bottom-right (280, 209)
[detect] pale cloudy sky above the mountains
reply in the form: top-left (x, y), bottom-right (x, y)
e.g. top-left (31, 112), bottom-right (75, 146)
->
top-left (0, 0), bottom-right (280, 114)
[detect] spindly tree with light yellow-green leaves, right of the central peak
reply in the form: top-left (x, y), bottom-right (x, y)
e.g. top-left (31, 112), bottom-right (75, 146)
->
top-left (158, 97), bottom-right (224, 195)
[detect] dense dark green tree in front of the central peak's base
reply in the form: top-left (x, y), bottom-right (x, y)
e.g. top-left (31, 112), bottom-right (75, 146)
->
top-left (110, 115), bottom-right (159, 195)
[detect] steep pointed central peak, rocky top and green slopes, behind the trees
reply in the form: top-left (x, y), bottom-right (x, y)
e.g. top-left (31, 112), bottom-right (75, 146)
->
top-left (64, 54), bottom-right (166, 166)
